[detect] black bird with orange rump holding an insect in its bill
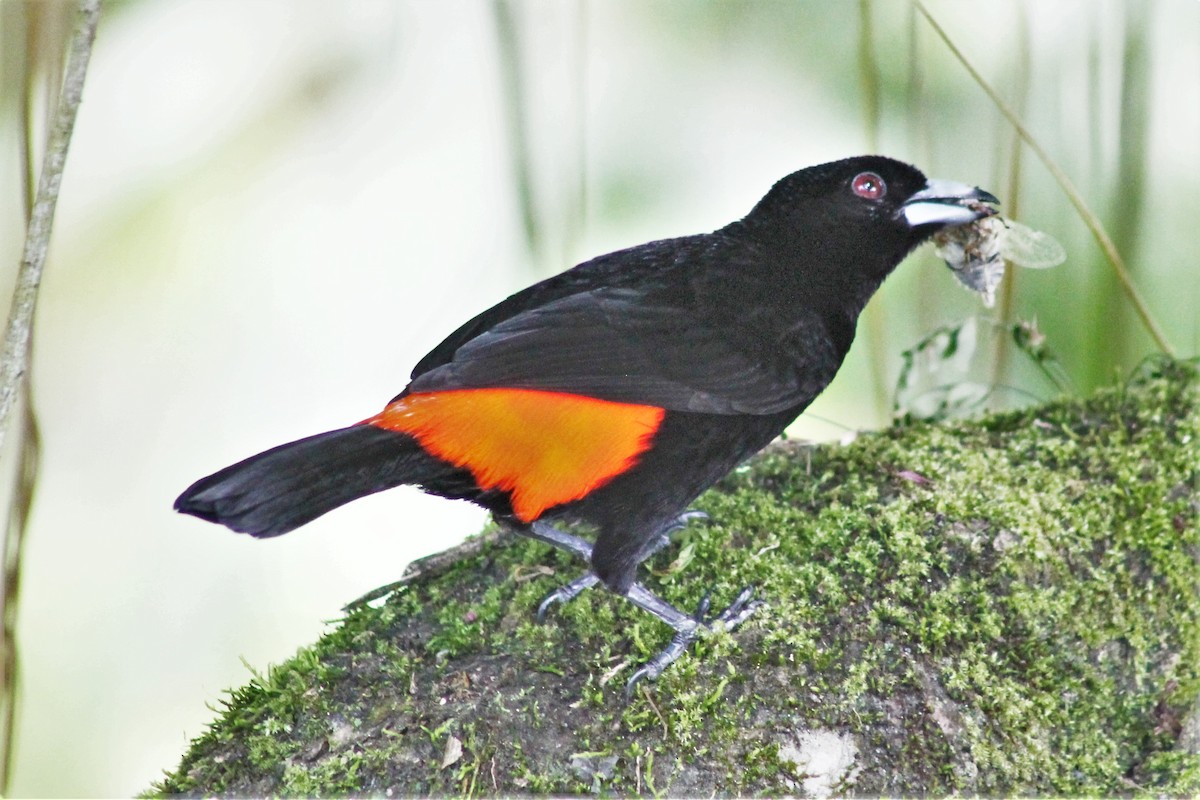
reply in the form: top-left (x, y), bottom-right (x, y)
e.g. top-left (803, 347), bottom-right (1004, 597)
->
top-left (174, 156), bottom-right (998, 692)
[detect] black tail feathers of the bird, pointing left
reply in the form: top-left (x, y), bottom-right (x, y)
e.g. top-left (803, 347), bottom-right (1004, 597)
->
top-left (175, 423), bottom-right (457, 536)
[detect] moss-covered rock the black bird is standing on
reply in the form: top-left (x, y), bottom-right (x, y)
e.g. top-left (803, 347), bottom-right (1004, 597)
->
top-left (154, 361), bottom-right (1200, 796)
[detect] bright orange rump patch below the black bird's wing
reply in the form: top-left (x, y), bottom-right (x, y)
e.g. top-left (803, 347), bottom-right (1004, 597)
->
top-left (366, 389), bottom-right (665, 522)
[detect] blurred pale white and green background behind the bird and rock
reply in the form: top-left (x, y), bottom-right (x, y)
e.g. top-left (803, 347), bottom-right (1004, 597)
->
top-left (0, 0), bottom-right (1200, 796)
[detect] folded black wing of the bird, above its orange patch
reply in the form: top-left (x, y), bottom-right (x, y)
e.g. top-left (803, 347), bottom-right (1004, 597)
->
top-left (406, 235), bottom-right (840, 414)
